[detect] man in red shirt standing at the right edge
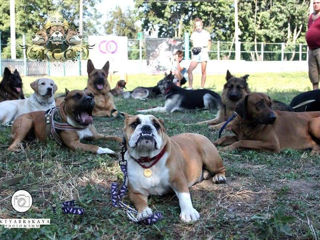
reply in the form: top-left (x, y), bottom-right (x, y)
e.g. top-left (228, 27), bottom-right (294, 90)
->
top-left (306, 0), bottom-right (320, 90)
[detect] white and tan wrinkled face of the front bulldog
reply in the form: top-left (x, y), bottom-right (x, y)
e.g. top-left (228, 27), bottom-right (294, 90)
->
top-left (123, 114), bottom-right (165, 156)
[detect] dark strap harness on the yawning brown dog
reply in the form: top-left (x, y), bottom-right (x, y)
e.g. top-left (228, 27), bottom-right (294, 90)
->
top-left (45, 107), bottom-right (83, 145)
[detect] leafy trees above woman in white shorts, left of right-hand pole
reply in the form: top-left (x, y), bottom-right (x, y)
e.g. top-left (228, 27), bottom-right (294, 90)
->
top-left (136, 0), bottom-right (234, 41)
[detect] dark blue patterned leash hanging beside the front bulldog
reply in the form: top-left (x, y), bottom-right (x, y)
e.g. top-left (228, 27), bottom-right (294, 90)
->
top-left (110, 144), bottom-right (163, 225)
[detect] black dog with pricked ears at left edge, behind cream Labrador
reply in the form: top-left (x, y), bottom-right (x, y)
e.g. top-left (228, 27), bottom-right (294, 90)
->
top-left (0, 67), bottom-right (24, 102)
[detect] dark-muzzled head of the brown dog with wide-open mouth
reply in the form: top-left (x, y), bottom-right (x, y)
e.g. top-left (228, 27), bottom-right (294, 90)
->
top-left (64, 90), bottom-right (94, 126)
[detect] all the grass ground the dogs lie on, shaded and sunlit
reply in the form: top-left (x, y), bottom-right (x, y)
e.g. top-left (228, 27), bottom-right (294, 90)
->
top-left (0, 73), bottom-right (320, 239)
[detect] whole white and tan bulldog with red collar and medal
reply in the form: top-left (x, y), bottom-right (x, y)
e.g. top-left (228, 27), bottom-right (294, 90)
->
top-left (123, 115), bottom-right (226, 222)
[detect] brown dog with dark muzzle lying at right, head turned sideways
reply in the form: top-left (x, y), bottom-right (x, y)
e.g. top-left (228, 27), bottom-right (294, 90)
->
top-left (215, 93), bottom-right (320, 154)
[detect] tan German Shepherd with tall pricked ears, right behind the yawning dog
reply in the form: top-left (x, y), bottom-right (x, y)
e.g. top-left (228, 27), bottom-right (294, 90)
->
top-left (87, 59), bottom-right (119, 117)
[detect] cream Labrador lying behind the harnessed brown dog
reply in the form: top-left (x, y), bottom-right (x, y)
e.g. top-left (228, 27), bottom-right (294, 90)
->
top-left (0, 78), bottom-right (57, 125)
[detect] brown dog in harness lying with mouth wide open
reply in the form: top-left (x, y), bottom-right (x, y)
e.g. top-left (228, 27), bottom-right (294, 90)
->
top-left (8, 90), bottom-right (122, 154)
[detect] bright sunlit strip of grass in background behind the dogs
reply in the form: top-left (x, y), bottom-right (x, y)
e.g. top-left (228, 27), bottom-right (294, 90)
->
top-left (23, 72), bottom-right (311, 95)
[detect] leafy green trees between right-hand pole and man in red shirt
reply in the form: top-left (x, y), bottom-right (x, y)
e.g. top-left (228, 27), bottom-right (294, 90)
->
top-left (239, 0), bottom-right (309, 60)
